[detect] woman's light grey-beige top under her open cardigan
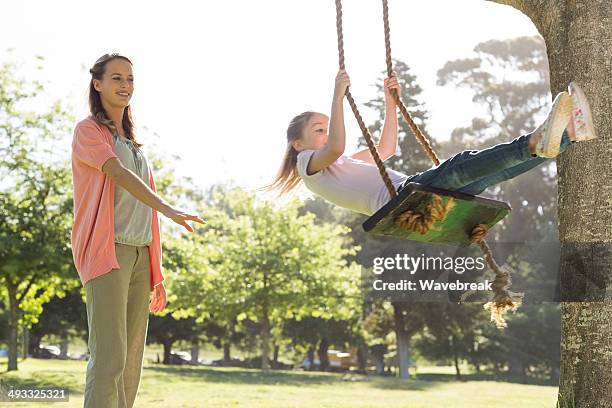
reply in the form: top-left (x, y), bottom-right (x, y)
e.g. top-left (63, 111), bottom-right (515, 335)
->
top-left (113, 133), bottom-right (153, 246)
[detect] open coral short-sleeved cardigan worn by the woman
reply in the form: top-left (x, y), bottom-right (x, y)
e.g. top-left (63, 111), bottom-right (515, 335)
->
top-left (71, 116), bottom-right (164, 290)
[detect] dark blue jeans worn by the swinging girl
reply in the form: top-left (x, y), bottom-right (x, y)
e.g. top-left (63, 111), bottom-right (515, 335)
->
top-left (398, 131), bottom-right (572, 195)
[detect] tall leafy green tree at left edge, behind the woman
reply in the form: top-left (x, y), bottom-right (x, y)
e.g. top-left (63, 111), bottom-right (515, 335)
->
top-left (0, 58), bottom-right (79, 371)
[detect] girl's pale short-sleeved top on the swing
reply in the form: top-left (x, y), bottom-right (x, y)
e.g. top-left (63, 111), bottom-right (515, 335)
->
top-left (297, 150), bottom-right (408, 215)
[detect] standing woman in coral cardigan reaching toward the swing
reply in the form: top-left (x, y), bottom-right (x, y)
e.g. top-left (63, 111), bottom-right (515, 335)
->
top-left (71, 54), bottom-right (204, 407)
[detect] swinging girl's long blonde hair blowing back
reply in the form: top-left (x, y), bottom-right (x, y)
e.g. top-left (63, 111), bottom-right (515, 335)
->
top-left (264, 111), bottom-right (315, 195)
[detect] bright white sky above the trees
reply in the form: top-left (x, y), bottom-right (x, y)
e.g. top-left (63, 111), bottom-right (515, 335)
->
top-left (0, 0), bottom-right (537, 193)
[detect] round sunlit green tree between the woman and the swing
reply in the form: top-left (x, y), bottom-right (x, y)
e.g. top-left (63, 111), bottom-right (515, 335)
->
top-left (166, 189), bottom-right (358, 370)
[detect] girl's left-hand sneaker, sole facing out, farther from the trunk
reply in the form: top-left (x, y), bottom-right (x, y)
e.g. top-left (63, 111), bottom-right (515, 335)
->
top-left (531, 92), bottom-right (572, 159)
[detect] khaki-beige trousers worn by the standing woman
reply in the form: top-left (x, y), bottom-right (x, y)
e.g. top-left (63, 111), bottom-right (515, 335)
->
top-left (84, 244), bottom-right (150, 408)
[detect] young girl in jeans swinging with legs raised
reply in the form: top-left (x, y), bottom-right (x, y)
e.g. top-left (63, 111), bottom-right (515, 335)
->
top-left (270, 70), bottom-right (596, 215)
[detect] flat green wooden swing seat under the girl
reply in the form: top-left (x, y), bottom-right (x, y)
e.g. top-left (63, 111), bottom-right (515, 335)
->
top-left (363, 183), bottom-right (511, 246)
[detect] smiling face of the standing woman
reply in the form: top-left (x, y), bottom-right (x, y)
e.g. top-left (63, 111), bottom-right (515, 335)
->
top-left (93, 58), bottom-right (134, 108)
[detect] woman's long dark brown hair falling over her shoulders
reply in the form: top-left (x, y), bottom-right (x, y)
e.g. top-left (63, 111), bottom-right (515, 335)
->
top-left (89, 53), bottom-right (142, 147)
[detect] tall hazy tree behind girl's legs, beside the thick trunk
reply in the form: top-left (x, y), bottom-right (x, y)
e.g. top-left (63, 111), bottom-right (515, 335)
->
top-left (438, 37), bottom-right (557, 242)
